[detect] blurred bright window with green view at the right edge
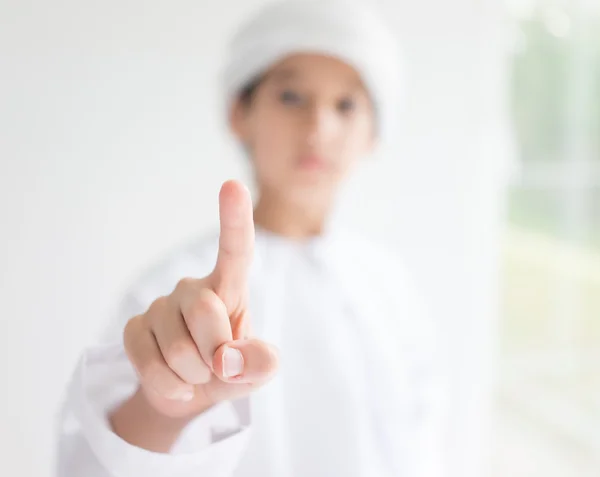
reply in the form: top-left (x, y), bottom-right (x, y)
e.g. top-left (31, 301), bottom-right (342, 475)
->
top-left (494, 0), bottom-right (600, 477)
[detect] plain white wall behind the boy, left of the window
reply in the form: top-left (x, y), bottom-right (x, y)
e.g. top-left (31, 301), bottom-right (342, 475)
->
top-left (0, 0), bottom-right (505, 477)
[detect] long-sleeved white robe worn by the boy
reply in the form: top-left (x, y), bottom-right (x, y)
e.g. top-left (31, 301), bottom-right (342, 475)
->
top-left (58, 230), bottom-right (444, 477)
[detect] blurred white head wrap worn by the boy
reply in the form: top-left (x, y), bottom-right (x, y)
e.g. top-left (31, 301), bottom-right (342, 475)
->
top-left (223, 0), bottom-right (401, 147)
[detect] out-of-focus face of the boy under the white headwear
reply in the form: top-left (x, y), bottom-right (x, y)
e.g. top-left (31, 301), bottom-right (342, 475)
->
top-left (231, 54), bottom-right (375, 203)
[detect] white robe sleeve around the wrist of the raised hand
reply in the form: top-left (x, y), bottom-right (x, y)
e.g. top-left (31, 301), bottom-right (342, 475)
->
top-left (56, 290), bottom-right (249, 477)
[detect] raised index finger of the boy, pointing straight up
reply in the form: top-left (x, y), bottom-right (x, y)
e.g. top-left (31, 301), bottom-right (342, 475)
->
top-left (213, 181), bottom-right (254, 296)
